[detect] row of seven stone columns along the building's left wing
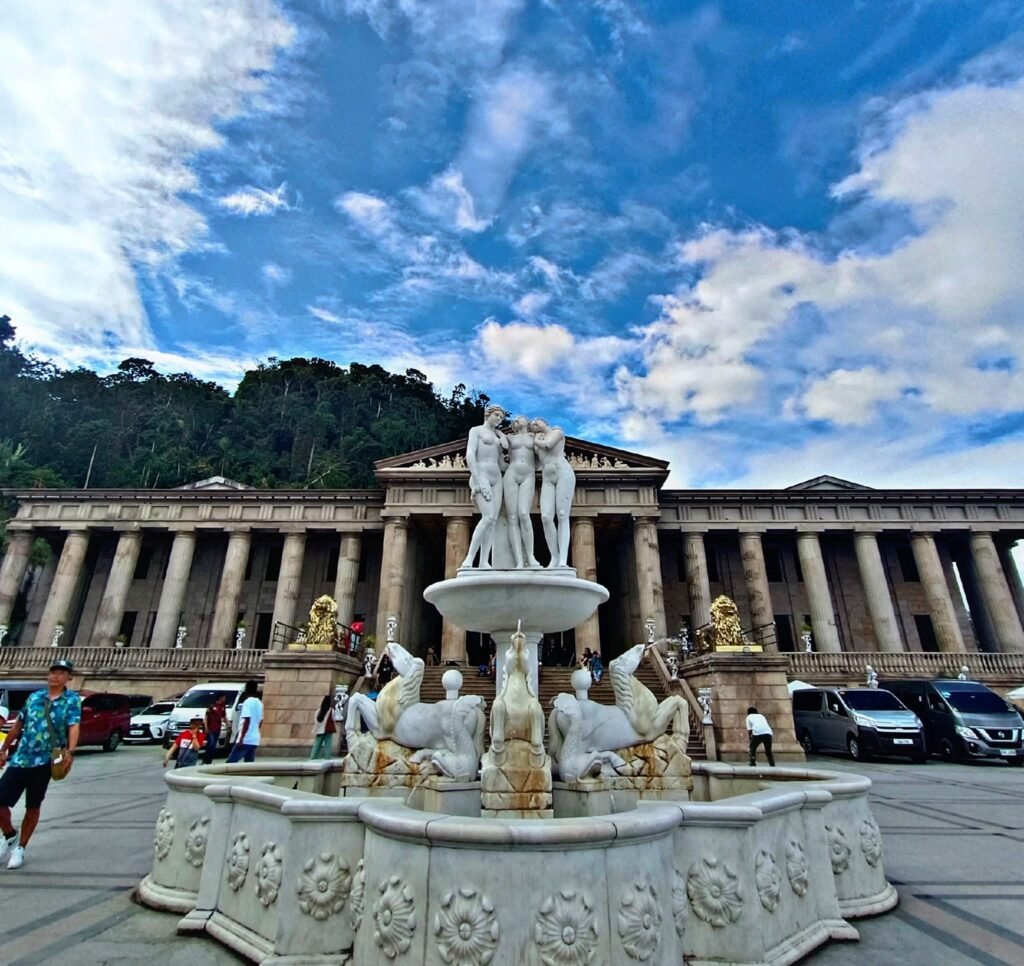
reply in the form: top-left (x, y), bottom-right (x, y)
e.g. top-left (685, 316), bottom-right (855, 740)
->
top-left (0, 529), bottom-right (361, 648)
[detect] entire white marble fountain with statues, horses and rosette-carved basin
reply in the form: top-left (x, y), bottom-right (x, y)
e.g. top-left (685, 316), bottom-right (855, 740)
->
top-left (139, 409), bottom-right (897, 966)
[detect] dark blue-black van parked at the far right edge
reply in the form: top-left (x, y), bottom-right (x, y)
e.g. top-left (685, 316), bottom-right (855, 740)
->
top-left (885, 679), bottom-right (1024, 765)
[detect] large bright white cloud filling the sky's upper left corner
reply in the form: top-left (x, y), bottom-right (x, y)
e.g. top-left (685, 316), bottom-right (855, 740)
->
top-left (0, 0), bottom-right (294, 361)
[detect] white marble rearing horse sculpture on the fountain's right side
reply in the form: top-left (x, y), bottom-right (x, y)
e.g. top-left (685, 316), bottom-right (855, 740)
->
top-left (548, 644), bottom-right (690, 761)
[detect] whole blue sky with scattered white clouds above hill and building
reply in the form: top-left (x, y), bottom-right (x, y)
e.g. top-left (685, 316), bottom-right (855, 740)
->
top-left (0, 0), bottom-right (1024, 487)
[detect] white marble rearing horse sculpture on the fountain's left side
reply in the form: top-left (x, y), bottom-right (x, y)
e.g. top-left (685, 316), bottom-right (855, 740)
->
top-left (345, 641), bottom-right (486, 782)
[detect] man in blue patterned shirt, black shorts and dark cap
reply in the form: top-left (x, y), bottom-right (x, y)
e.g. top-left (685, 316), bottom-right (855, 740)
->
top-left (0, 661), bottom-right (82, 869)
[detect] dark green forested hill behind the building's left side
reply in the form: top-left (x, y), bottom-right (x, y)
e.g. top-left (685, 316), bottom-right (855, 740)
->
top-left (0, 317), bottom-right (486, 489)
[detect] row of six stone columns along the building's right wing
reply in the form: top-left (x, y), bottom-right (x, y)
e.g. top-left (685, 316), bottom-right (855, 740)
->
top-left (683, 531), bottom-right (1024, 653)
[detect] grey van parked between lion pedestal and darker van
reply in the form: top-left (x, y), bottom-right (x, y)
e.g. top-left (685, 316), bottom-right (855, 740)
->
top-left (793, 687), bottom-right (928, 762)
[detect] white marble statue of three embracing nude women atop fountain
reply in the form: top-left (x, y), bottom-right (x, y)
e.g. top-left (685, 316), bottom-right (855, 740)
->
top-left (462, 406), bottom-right (575, 570)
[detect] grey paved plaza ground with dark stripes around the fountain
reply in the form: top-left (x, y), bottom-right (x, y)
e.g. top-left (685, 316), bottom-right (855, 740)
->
top-left (0, 747), bottom-right (1024, 966)
